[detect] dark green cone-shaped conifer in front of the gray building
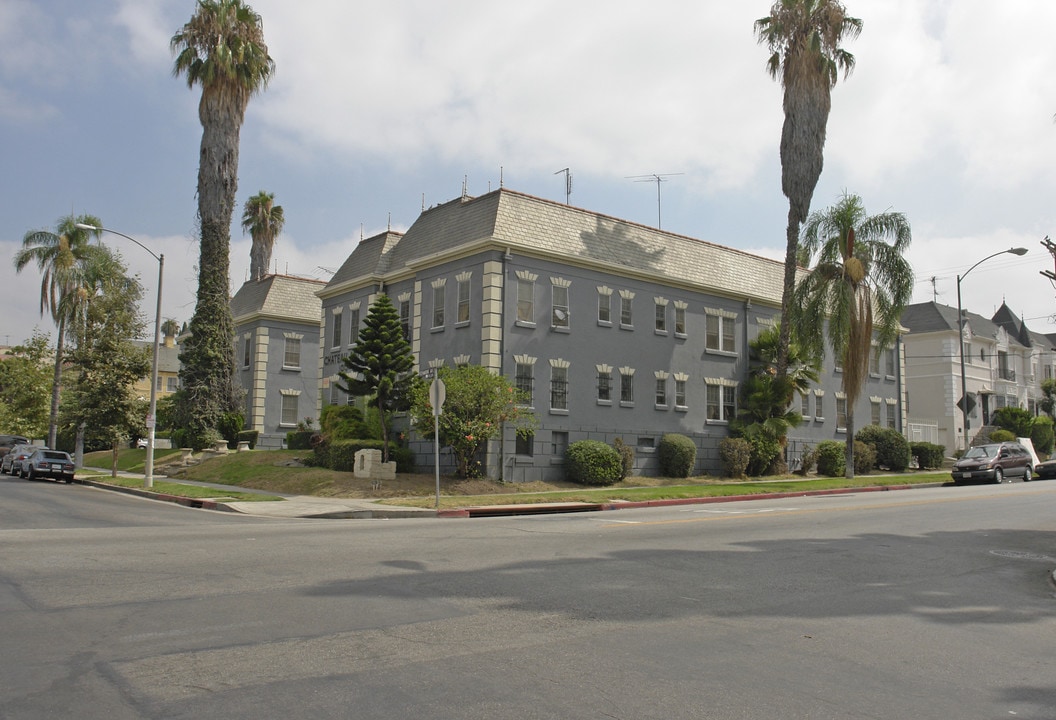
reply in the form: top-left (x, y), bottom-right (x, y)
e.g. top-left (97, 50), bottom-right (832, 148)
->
top-left (338, 295), bottom-right (418, 462)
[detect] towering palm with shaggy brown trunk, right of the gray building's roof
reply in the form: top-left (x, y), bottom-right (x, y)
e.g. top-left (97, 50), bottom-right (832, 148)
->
top-left (755, 0), bottom-right (862, 377)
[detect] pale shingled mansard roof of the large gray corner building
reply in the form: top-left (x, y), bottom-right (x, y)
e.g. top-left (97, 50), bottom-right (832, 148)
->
top-left (327, 188), bottom-right (784, 305)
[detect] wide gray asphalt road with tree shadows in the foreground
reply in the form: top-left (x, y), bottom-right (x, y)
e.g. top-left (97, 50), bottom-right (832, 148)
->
top-left (0, 476), bottom-right (1056, 720)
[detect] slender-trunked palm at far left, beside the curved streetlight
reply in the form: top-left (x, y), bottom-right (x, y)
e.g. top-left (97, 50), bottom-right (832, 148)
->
top-left (15, 215), bottom-right (102, 448)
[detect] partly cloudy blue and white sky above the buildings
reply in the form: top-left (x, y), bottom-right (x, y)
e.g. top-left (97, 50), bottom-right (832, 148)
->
top-left (0, 0), bottom-right (1056, 344)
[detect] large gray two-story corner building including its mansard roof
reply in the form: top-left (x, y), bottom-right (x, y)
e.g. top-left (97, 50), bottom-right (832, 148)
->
top-left (318, 188), bottom-right (904, 481)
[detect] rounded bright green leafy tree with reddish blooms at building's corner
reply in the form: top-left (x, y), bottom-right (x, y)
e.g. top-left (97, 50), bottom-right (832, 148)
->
top-left (411, 365), bottom-right (536, 477)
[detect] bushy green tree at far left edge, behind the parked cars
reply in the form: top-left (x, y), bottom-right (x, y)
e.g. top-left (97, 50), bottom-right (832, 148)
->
top-left (0, 330), bottom-right (52, 437)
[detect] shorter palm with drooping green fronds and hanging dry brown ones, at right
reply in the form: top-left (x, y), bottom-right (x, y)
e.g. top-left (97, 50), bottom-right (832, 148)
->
top-left (793, 192), bottom-right (913, 477)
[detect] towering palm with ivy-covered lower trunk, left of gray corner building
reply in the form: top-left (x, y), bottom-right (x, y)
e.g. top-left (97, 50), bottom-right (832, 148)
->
top-left (170, 0), bottom-right (275, 447)
